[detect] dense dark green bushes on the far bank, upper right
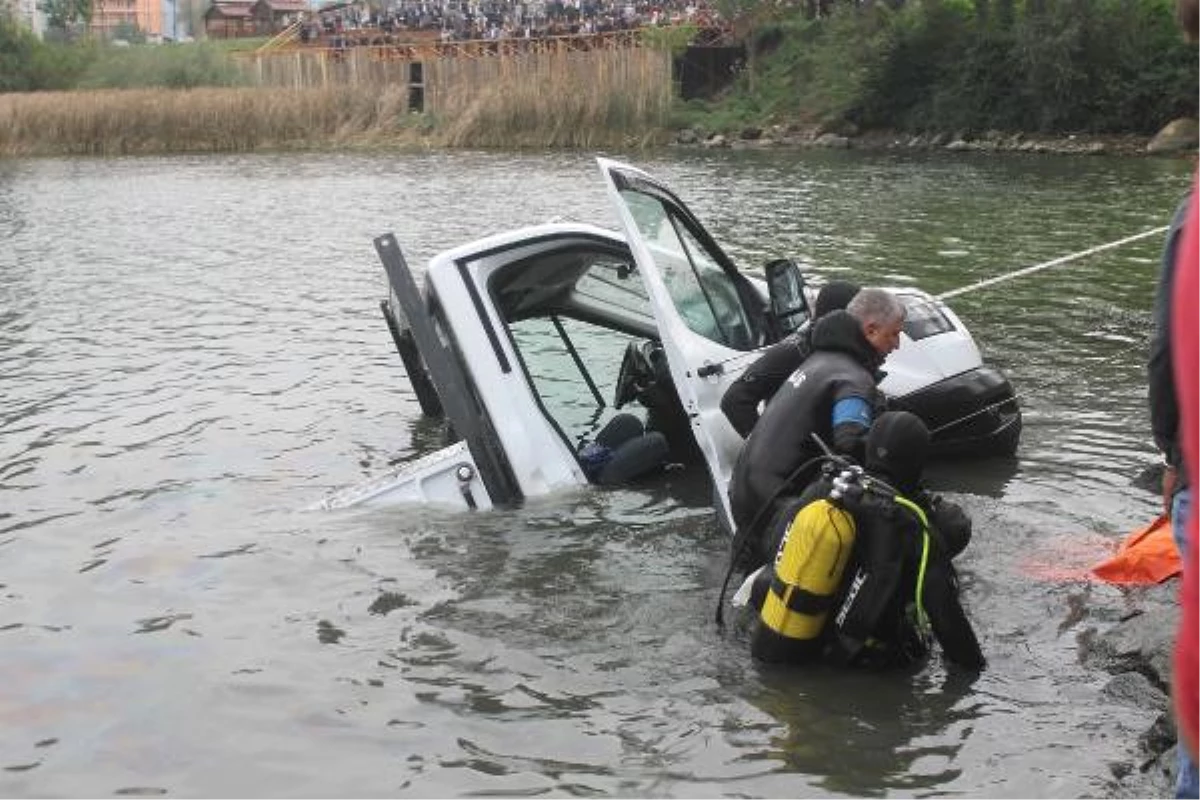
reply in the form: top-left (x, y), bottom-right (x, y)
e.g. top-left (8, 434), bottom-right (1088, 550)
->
top-left (691, 0), bottom-right (1200, 133)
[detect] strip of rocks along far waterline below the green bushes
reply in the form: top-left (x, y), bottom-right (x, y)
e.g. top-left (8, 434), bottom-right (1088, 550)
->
top-left (672, 119), bottom-right (1200, 156)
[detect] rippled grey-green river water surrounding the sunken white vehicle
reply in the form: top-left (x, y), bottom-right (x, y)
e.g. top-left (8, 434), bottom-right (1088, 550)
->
top-left (0, 151), bottom-right (1188, 800)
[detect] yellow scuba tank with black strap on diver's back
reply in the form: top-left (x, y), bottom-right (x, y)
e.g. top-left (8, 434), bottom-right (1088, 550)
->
top-left (751, 498), bottom-right (856, 661)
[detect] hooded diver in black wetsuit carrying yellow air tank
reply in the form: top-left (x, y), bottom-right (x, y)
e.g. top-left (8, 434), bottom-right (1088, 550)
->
top-left (751, 411), bottom-right (985, 670)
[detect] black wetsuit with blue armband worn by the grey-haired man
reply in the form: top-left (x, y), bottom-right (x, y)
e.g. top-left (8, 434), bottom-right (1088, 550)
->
top-left (730, 311), bottom-right (883, 551)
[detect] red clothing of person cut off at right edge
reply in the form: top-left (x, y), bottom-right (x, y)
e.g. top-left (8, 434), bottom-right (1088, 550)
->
top-left (1171, 172), bottom-right (1200, 756)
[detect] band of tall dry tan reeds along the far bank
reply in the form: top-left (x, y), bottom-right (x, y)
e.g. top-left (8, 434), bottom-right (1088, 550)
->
top-left (0, 48), bottom-right (671, 156)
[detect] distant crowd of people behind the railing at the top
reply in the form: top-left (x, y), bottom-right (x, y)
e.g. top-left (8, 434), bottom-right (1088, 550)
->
top-left (299, 0), bottom-right (720, 47)
